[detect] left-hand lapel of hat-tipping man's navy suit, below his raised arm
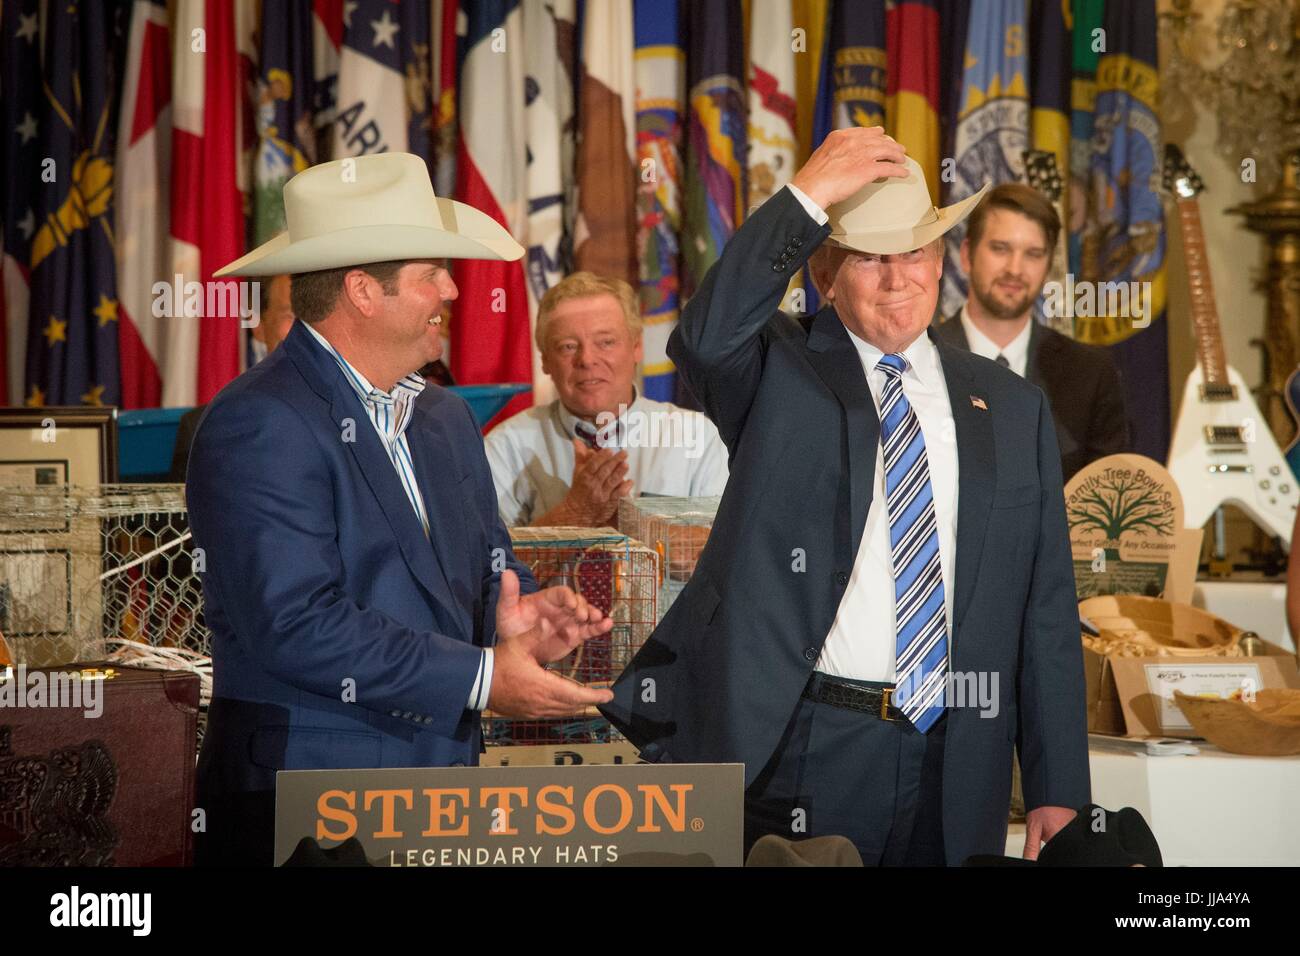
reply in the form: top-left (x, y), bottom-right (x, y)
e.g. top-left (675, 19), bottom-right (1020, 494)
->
top-left (807, 306), bottom-right (880, 561)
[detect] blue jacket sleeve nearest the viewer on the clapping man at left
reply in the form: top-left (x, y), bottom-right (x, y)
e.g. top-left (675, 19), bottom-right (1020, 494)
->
top-left (186, 393), bottom-right (490, 735)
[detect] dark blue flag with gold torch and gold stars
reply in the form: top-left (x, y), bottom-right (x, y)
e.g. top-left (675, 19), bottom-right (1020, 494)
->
top-left (22, 4), bottom-right (125, 406)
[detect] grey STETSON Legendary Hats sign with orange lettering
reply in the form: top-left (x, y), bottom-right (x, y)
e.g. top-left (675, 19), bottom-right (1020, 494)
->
top-left (276, 763), bottom-right (744, 866)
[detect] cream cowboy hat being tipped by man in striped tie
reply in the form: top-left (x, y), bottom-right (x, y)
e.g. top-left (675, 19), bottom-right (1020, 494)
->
top-left (826, 156), bottom-right (989, 255)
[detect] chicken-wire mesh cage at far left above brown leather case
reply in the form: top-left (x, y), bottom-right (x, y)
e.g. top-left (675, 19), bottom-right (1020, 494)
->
top-left (0, 485), bottom-right (211, 704)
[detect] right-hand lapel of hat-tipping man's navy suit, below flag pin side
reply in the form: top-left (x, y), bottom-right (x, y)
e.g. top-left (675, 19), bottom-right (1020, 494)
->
top-left (936, 338), bottom-right (997, 639)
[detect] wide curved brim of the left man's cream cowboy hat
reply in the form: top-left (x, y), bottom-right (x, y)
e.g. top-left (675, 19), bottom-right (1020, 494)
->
top-left (213, 198), bottom-right (524, 277)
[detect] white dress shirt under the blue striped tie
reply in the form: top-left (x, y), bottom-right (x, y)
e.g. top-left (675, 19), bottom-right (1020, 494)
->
top-left (816, 325), bottom-right (957, 683)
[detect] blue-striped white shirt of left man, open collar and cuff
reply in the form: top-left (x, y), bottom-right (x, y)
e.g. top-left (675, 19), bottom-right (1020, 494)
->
top-left (303, 323), bottom-right (493, 710)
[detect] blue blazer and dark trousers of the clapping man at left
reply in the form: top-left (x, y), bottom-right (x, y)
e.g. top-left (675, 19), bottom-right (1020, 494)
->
top-left (186, 323), bottom-right (537, 864)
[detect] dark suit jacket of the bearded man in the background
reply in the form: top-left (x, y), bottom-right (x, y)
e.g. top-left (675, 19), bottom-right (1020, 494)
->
top-left (936, 316), bottom-right (1132, 481)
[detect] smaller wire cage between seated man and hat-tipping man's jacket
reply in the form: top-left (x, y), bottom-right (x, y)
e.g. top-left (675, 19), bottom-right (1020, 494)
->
top-left (619, 496), bottom-right (722, 619)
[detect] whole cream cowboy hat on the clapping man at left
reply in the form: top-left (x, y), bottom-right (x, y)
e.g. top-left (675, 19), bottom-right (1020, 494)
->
top-left (213, 152), bottom-right (524, 276)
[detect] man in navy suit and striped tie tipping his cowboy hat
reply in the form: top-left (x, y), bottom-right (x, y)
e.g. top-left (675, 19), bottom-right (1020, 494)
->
top-left (603, 127), bottom-right (1089, 865)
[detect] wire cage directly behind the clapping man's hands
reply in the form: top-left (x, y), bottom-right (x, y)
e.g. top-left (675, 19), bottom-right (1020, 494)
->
top-left (482, 528), bottom-right (659, 747)
